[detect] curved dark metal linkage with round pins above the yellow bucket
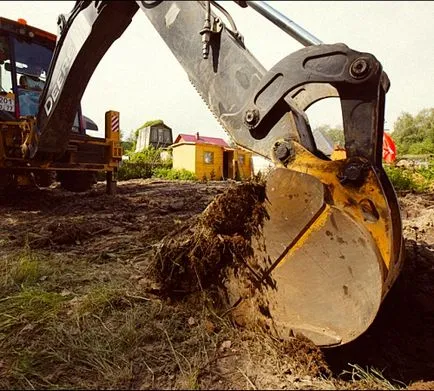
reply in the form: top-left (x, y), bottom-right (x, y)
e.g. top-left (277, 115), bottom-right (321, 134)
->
top-left (244, 44), bottom-right (389, 166)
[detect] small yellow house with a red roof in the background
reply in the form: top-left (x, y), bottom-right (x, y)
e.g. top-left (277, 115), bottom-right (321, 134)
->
top-left (171, 133), bottom-right (252, 180)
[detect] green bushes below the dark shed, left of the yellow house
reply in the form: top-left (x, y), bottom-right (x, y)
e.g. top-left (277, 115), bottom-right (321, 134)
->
top-left (118, 146), bottom-right (172, 181)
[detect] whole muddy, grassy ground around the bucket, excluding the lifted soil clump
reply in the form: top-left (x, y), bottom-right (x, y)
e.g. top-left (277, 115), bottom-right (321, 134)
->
top-left (0, 180), bottom-right (434, 389)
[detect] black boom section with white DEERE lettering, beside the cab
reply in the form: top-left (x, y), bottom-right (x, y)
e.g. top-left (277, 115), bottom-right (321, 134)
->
top-left (34, 1), bottom-right (138, 156)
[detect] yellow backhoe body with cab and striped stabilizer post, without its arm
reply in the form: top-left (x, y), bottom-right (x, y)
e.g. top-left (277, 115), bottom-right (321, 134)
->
top-left (0, 17), bottom-right (122, 192)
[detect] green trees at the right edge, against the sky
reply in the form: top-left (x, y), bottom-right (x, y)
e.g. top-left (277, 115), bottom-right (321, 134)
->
top-left (392, 108), bottom-right (434, 155)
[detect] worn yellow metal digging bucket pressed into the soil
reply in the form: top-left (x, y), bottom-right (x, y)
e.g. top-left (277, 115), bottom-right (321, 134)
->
top-left (227, 143), bottom-right (403, 347)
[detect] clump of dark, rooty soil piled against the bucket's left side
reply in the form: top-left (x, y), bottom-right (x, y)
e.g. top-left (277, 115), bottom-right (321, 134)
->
top-left (152, 182), bottom-right (267, 297)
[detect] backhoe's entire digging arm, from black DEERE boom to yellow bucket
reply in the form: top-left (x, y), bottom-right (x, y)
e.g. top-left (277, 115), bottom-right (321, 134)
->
top-left (4, 0), bottom-right (404, 347)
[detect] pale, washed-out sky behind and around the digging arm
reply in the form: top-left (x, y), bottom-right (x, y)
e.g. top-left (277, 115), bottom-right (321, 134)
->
top-left (0, 1), bottom-right (434, 140)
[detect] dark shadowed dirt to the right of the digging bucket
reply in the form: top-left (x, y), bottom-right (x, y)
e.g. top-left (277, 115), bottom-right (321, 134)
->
top-left (325, 193), bottom-right (434, 384)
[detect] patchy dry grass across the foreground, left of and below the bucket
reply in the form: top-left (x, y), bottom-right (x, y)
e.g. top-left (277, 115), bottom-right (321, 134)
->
top-left (0, 246), bottom-right (410, 389)
